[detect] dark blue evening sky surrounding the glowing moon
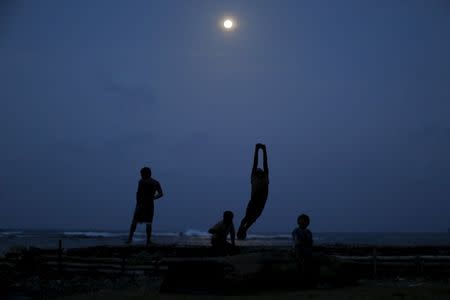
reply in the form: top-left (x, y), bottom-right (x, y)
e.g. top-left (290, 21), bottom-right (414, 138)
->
top-left (0, 0), bottom-right (450, 231)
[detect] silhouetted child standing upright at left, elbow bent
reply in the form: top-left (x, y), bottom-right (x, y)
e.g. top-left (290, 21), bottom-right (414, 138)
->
top-left (127, 167), bottom-right (163, 247)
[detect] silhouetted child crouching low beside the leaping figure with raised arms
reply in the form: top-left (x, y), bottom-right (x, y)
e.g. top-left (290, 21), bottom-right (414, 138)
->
top-left (208, 211), bottom-right (235, 253)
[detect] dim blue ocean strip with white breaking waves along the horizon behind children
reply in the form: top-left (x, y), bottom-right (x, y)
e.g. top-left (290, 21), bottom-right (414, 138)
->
top-left (0, 229), bottom-right (450, 254)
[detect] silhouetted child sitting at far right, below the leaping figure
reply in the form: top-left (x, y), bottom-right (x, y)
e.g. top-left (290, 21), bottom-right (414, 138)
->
top-left (292, 214), bottom-right (313, 285)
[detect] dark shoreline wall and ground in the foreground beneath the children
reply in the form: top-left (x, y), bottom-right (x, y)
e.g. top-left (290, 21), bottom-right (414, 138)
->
top-left (0, 245), bottom-right (450, 299)
